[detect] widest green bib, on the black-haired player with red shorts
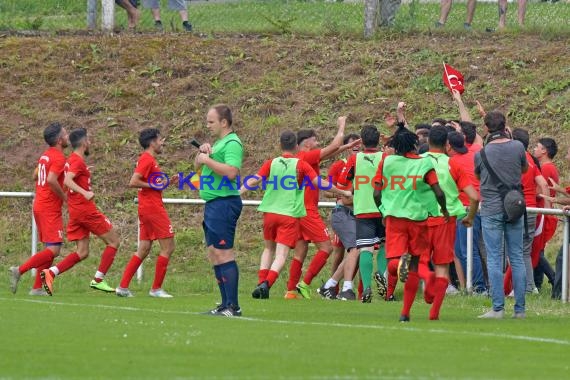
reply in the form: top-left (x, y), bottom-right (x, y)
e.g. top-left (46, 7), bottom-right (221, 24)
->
top-left (380, 155), bottom-right (439, 221)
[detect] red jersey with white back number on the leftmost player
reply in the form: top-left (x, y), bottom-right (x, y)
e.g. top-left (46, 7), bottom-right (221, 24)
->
top-left (34, 147), bottom-right (65, 212)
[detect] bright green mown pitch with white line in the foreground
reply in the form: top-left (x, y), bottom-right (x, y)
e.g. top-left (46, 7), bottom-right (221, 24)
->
top-left (0, 271), bottom-right (570, 379)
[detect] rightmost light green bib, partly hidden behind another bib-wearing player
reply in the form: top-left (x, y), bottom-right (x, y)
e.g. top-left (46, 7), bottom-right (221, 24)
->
top-left (422, 152), bottom-right (467, 218)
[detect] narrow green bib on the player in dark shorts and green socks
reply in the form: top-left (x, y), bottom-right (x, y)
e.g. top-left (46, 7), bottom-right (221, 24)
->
top-left (352, 152), bottom-right (382, 215)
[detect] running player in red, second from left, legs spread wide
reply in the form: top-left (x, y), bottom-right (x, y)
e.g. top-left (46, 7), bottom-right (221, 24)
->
top-left (40, 128), bottom-right (119, 296)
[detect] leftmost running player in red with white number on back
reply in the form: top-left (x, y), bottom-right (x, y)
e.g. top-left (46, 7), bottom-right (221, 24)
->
top-left (10, 123), bottom-right (69, 296)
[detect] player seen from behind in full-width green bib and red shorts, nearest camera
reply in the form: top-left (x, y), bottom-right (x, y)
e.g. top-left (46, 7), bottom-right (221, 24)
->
top-left (374, 121), bottom-right (449, 322)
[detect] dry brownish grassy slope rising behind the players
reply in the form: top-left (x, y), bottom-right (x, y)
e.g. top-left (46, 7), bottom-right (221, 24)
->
top-left (0, 33), bottom-right (570, 260)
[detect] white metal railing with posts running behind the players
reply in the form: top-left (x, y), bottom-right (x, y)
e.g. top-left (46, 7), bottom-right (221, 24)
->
top-left (0, 192), bottom-right (570, 303)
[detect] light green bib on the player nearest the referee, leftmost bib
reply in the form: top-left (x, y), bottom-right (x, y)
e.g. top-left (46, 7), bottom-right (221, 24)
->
top-left (257, 157), bottom-right (307, 218)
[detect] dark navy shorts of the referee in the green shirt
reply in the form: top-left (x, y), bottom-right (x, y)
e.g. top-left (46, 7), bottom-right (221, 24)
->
top-left (202, 195), bottom-right (243, 249)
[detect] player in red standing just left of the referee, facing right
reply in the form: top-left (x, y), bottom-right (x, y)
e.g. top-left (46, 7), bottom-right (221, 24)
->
top-left (115, 128), bottom-right (178, 298)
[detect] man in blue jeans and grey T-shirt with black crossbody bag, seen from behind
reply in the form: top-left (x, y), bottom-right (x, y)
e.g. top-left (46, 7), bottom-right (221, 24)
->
top-left (475, 111), bottom-right (528, 319)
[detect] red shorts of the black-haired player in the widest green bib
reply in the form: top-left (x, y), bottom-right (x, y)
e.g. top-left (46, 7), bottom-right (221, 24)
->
top-left (384, 216), bottom-right (429, 259)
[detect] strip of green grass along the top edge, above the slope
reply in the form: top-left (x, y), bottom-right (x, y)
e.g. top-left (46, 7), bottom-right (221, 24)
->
top-left (0, 0), bottom-right (570, 35)
